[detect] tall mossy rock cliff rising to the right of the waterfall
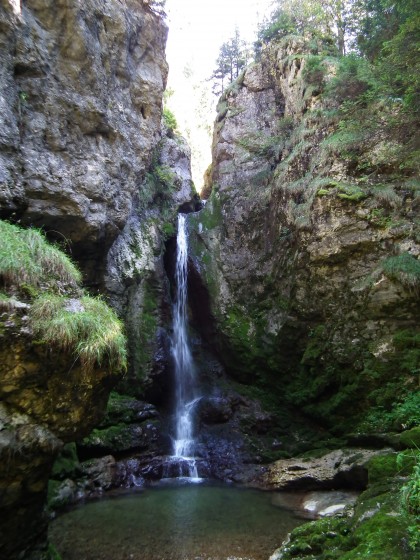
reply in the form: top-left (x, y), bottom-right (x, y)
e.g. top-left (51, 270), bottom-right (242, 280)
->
top-left (191, 39), bottom-right (420, 444)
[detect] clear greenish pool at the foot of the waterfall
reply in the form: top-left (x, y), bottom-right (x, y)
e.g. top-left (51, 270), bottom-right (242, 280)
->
top-left (50, 484), bottom-right (302, 560)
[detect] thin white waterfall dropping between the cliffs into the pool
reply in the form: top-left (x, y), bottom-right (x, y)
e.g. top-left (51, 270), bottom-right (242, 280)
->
top-left (172, 214), bottom-right (199, 478)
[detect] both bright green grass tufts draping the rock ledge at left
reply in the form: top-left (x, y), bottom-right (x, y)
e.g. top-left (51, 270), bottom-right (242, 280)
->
top-left (0, 221), bottom-right (126, 370)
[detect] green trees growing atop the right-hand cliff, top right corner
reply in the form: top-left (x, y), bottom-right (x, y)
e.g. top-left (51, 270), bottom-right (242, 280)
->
top-left (255, 0), bottom-right (420, 113)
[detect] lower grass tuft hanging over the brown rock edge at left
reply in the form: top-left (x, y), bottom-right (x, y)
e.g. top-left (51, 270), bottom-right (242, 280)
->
top-left (29, 294), bottom-right (127, 370)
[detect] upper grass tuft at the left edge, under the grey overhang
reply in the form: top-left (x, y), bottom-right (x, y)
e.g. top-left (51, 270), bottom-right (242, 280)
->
top-left (0, 220), bottom-right (82, 288)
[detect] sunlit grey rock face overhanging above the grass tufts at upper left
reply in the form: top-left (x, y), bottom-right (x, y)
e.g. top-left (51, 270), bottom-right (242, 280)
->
top-left (0, 0), bottom-right (167, 282)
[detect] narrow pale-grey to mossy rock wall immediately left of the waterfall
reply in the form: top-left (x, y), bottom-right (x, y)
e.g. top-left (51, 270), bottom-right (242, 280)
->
top-left (105, 124), bottom-right (198, 398)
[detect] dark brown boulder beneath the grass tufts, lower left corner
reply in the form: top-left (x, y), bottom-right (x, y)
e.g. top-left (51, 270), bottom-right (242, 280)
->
top-left (0, 308), bottom-right (118, 559)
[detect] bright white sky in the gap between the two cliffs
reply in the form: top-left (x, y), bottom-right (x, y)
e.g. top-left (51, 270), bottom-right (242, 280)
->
top-left (162, 0), bottom-right (273, 190)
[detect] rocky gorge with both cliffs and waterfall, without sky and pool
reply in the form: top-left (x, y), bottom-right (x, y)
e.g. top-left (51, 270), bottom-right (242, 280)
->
top-left (0, 0), bottom-right (420, 560)
